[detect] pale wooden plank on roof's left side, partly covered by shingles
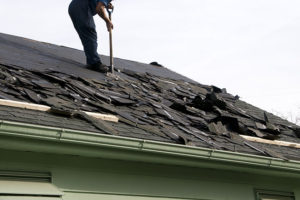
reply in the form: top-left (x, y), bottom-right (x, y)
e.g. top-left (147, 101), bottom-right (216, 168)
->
top-left (0, 99), bottom-right (119, 122)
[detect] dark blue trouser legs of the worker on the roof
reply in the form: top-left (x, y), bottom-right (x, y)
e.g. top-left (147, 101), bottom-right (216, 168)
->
top-left (69, 0), bottom-right (101, 65)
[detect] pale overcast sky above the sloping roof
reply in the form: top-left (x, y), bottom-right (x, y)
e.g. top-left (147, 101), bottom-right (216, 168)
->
top-left (0, 0), bottom-right (300, 124)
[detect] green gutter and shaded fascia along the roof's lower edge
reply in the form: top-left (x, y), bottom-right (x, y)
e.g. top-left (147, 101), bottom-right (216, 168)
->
top-left (0, 121), bottom-right (300, 177)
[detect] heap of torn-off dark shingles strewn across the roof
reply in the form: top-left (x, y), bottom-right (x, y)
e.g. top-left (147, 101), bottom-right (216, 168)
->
top-left (0, 65), bottom-right (300, 157)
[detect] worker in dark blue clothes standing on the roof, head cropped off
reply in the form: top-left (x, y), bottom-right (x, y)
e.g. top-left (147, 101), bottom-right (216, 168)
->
top-left (69, 0), bottom-right (113, 73)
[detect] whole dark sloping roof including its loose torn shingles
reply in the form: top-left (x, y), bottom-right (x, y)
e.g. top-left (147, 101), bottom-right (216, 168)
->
top-left (0, 34), bottom-right (300, 160)
